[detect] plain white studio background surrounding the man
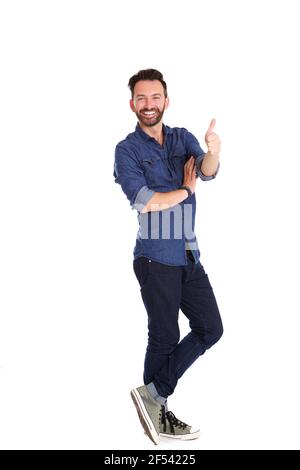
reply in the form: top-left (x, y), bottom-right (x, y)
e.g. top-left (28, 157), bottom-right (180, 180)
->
top-left (0, 0), bottom-right (300, 450)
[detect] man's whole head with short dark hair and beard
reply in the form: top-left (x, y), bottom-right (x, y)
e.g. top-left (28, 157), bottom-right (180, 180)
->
top-left (128, 69), bottom-right (169, 127)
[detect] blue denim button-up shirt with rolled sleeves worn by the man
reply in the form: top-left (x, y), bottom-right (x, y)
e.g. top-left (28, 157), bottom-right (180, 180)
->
top-left (114, 124), bottom-right (219, 266)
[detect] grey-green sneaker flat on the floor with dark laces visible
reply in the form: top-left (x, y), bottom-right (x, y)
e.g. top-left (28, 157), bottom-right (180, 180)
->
top-left (160, 410), bottom-right (200, 441)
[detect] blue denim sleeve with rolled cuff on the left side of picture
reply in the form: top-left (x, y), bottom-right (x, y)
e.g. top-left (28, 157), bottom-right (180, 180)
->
top-left (114, 145), bottom-right (154, 212)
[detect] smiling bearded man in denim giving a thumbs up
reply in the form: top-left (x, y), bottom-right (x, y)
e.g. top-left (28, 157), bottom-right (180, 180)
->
top-left (114, 69), bottom-right (223, 444)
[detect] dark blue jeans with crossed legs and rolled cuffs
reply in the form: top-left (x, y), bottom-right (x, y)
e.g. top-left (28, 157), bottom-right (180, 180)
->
top-left (133, 252), bottom-right (223, 397)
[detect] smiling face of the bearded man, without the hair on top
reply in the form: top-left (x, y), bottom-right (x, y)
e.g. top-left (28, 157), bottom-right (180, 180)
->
top-left (130, 80), bottom-right (169, 127)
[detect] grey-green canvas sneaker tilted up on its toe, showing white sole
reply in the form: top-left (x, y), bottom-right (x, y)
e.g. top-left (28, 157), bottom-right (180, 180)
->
top-left (130, 385), bottom-right (165, 444)
